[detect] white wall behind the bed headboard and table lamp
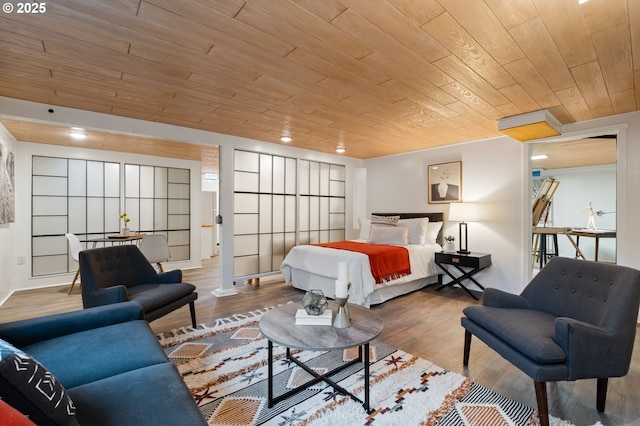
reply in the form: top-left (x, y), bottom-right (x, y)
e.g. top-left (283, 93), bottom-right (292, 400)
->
top-left (365, 138), bottom-right (525, 292)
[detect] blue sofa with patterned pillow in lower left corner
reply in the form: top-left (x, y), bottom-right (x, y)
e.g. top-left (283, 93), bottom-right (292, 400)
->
top-left (0, 302), bottom-right (207, 426)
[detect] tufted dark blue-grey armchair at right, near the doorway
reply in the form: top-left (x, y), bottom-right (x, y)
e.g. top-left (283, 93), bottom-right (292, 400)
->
top-left (461, 257), bottom-right (640, 425)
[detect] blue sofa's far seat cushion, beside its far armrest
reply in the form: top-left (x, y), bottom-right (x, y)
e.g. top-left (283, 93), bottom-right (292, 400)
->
top-left (23, 320), bottom-right (168, 389)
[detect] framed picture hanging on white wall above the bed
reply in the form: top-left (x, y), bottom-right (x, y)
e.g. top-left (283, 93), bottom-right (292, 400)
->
top-left (427, 161), bottom-right (462, 204)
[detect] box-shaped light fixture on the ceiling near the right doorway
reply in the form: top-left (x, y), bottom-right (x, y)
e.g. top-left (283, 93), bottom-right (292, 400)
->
top-left (498, 109), bottom-right (562, 142)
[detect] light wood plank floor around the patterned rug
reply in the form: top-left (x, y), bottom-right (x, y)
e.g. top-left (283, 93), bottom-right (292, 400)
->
top-left (0, 258), bottom-right (640, 425)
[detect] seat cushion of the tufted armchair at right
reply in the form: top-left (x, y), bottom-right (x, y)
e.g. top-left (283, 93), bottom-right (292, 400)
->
top-left (463, 305), bottom-right (567, 364)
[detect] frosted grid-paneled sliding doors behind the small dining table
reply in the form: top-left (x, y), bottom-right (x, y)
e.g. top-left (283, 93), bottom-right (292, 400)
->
top-left (31, 155), bottom-right (191, 277)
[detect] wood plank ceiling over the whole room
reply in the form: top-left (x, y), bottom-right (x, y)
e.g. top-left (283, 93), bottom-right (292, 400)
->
top-left (0, 0), bottom-right (640, 164)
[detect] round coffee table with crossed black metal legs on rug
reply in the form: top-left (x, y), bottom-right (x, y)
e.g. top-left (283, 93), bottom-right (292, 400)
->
top-left (259, 301), bottom-right (384, 412)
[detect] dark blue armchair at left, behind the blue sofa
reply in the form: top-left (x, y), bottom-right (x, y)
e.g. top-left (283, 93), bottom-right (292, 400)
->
top-left (79, 244), bottom-right (198, 328)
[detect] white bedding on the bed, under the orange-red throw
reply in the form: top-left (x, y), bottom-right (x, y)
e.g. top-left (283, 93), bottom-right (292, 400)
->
top-left (280, 240), bottom-right (442, 307)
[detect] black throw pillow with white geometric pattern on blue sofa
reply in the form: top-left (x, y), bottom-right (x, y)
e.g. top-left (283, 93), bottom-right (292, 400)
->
top-left (0, 339), bottom-right (78, 426)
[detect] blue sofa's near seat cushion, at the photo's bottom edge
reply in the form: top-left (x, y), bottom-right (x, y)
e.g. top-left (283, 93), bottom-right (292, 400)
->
top-left (69, 362), bottom-right (207, 426)
